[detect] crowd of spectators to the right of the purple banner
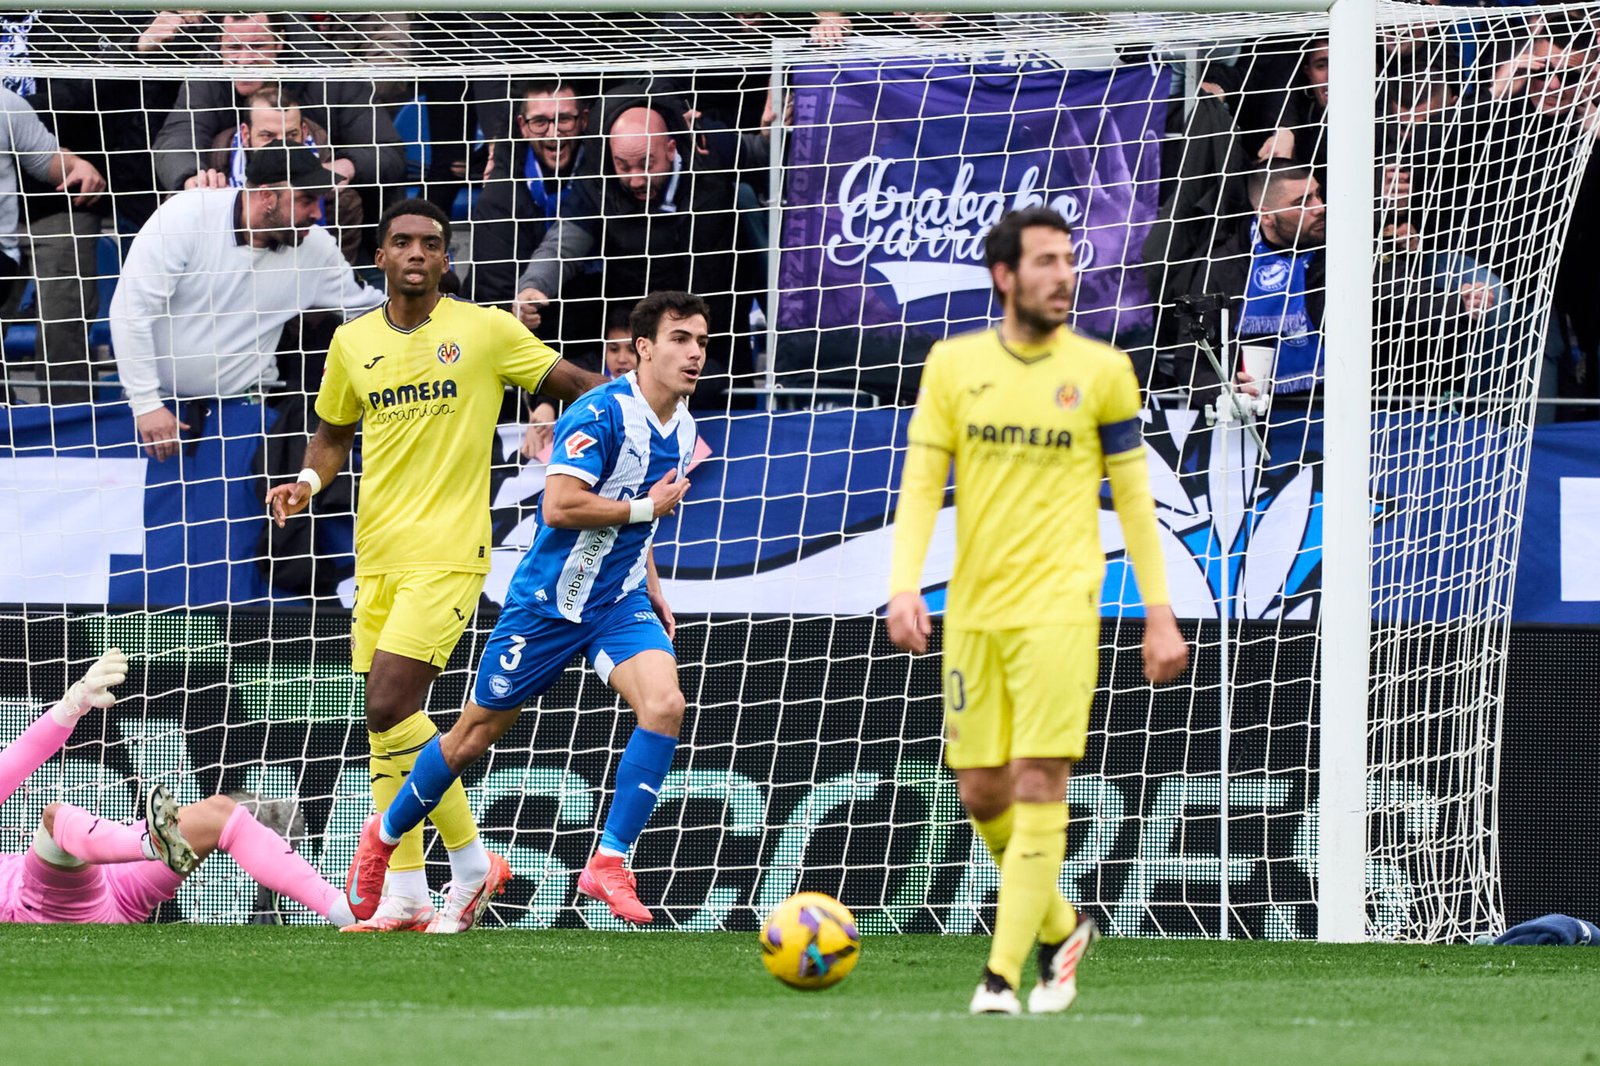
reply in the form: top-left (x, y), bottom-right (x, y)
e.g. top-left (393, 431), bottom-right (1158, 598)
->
top-left (1144, 11), bottom-right (1600, 419)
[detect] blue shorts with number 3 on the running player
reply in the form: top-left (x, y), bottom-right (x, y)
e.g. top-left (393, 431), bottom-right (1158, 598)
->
top-left (472, 589), bottom-right (674, 711)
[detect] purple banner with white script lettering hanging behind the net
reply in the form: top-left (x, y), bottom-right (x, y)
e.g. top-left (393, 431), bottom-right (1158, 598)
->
top-left (778, 59), bottom-right (1170, 338)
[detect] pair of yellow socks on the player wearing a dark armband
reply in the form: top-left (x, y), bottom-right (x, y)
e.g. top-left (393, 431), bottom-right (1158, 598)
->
top-left (974, 804), bottom-right (1077, 989)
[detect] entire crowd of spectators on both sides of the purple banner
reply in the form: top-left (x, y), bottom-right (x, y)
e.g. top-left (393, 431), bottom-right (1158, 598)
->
top-left (0, 11), bottom-right (1600, 435)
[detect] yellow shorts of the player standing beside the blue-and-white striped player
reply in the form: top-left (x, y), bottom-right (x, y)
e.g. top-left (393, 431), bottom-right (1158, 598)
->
top-left (350, 570), bottom-right (476, 674)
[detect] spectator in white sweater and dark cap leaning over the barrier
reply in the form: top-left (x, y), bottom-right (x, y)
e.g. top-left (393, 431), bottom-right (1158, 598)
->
top-left (110, 142), bottom-right (384, 459)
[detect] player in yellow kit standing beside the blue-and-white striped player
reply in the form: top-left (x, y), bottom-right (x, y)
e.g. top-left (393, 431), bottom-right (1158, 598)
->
top-left (267, 200), bottom-right (605, 933)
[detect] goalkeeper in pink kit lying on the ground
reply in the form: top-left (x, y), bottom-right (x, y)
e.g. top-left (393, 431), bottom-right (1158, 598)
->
top-left (0, 648), bottom-right (355, 925)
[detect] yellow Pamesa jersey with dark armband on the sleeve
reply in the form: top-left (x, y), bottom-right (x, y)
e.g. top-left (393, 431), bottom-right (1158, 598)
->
top-left (907, 321), bottom-right (1142, 629)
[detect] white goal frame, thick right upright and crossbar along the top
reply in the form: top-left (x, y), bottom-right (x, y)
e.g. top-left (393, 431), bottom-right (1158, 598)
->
top-left (12, 0), bottom-right (1465, 941)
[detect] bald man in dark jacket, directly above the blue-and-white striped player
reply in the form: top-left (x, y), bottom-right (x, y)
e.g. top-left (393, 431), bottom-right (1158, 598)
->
top-left (517, 88), bottom-right (749, 408)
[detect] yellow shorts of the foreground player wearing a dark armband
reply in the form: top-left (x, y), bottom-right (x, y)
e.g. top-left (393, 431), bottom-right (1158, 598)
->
top-left (944, 623), bottom-right (1099, 770)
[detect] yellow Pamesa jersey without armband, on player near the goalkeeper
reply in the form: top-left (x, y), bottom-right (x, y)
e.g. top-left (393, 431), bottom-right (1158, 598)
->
top-left (317, 296), bottom-right (560, 575)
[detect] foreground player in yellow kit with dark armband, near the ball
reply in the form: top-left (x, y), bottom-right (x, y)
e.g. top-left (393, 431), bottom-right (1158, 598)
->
top-left (888, 208), bottom-right (1189, 1015)
